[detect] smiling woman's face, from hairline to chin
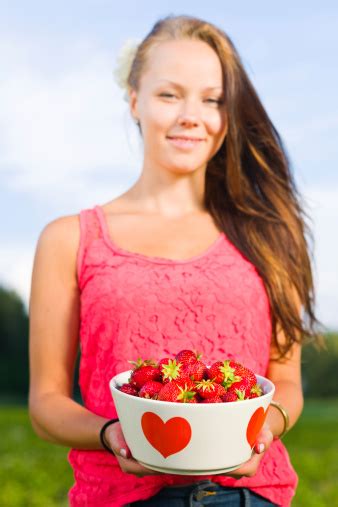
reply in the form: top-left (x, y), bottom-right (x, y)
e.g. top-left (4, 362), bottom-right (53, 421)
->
top-left (130, 39), bottom-right (227, 177)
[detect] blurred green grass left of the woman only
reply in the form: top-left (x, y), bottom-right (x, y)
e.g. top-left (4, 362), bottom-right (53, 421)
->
top-left (0, 406), bottom-right (73, 507)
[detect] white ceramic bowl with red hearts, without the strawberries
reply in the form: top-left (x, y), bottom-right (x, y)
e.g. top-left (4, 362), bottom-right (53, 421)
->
top-left (109, 370), bottom-right (275, 475)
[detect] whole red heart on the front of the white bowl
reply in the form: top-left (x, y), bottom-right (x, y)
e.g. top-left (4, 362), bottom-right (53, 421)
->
top-left (141, 412), bottom-right (192, 458)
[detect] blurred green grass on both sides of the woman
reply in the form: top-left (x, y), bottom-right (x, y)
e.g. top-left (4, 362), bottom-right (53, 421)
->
top-left (0, 399), bottom-right (338, 507)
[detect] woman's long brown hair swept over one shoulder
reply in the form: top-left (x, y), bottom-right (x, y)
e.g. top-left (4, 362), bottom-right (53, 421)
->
top-left (128, 15), bottom-right (321, 359)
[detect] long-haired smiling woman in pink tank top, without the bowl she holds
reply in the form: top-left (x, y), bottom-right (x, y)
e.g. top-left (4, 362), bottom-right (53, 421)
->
top-left (29, 16), bottom-right (317, 507)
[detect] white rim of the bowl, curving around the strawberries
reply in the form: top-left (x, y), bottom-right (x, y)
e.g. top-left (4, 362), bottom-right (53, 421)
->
top-left (109, 370), bottom-right (276, 407)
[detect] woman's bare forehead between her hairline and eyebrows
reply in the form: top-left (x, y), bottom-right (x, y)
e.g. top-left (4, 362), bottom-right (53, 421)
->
top-left (144, 39), bottom-right (223, 88)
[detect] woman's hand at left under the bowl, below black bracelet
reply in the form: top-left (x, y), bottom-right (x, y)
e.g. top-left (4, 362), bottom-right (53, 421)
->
top-left (104, 421), bottom-right (162, 477)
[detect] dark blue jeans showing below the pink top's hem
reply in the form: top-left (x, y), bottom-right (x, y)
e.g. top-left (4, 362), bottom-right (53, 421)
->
top-left (125, 480), bottom-right (278, 507)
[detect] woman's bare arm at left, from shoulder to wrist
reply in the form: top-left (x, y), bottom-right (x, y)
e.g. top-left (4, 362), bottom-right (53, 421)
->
top-left (28, 216), bottom-right (107, 449)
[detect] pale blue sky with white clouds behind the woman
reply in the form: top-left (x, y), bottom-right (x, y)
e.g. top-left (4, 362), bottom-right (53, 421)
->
top-left (0, 0), bottom-right (338, 329)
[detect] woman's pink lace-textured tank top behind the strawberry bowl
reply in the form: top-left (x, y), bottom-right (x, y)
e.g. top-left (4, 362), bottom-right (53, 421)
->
top-left (68, 206), bottom-right (298, 507)
